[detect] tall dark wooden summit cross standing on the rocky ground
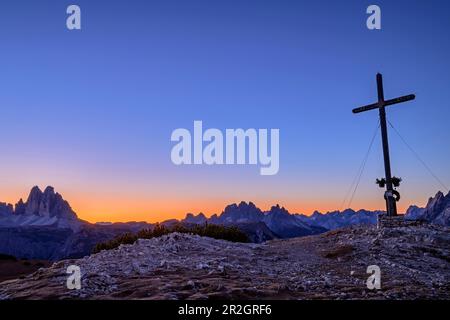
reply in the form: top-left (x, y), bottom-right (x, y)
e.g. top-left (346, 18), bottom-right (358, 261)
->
top-left (353, 73), bottom-right (416, 216)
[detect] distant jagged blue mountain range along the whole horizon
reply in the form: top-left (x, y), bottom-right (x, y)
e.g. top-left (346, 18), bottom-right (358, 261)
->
top-left (0, 187), bottom-right (450, 260)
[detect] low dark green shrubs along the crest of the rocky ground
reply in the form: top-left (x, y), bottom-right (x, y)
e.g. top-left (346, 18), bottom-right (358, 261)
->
top-left (92, 223), bottom-right (249, 253)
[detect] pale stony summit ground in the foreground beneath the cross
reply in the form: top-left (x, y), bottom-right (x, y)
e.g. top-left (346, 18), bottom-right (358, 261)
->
top-left (0, 225), bottom-right (450, 299)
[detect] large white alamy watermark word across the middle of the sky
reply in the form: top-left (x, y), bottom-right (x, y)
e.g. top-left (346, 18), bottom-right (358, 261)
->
top-left (171, 121), bottom-right (280, 175)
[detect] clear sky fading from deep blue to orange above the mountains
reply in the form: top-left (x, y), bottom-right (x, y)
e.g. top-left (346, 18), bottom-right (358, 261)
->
top-left (0, 0), bottom-right (450, 221)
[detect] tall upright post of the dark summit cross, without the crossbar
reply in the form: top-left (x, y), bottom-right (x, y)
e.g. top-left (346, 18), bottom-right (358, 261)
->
top-left (377, 73), bottom-right (397, 216)
